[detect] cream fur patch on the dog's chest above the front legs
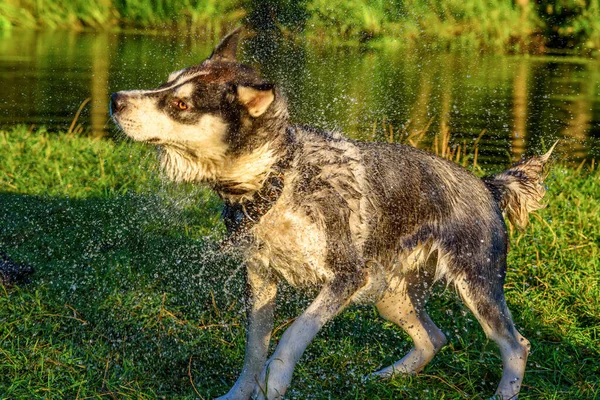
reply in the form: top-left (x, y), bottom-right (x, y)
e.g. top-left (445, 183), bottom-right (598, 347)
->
top-left (250, 193), bottom-right (333, 286)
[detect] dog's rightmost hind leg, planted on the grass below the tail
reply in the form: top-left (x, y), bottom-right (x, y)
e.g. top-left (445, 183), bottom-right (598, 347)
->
top-left (456, 279), bottom-right (530, 400)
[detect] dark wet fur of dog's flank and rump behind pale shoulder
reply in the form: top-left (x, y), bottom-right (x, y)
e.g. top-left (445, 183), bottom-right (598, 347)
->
top-left (360, 139), bottom-right (506, 274)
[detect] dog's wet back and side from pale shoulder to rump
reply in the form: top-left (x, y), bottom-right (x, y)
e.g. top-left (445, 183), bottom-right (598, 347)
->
top-left (286, 128), bottom-right (507, 284)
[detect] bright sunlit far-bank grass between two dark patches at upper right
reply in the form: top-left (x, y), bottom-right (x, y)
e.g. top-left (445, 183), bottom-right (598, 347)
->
top-left (307, 0), bottom-right (536, 49)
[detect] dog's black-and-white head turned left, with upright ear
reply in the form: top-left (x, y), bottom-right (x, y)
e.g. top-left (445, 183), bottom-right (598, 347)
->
top-left (110, 28), bottom-right (287, 191)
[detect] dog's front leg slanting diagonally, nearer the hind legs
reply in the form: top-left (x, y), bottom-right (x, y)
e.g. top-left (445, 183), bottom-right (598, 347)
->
top-left (253, 262), bottom-right (363, 400)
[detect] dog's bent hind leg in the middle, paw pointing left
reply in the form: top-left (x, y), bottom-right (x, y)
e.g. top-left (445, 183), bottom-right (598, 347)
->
top-left (373, 269), bottom-right (446, 378)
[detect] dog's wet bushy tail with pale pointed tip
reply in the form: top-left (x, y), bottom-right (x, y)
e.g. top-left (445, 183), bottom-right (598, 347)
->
top-left (483, 141), bottom-right (558, 228)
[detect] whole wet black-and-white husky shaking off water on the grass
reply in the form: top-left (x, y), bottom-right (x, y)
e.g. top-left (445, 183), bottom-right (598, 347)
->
top-left (110, 28), bottom-right (552, 399)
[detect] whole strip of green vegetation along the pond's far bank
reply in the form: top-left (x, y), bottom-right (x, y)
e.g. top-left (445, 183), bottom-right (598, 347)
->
top-left (0, 0), bottom-right (600, 52)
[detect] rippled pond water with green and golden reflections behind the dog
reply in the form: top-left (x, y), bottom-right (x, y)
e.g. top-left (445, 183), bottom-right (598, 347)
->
top-left (0, 32), bottom-right (600, 164)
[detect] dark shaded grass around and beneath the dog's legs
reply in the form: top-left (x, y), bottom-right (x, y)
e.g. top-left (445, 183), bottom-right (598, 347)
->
top-left (0, 194), bottom-right (600, 399)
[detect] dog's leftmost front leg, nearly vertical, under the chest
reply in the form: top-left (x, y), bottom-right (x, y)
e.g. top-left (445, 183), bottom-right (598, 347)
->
top-left (217, 266), bottom-right (277, 400)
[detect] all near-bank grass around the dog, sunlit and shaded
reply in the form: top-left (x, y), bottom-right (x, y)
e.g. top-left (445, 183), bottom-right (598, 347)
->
top-left (0, 127), bottom-right (600, 399)
